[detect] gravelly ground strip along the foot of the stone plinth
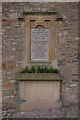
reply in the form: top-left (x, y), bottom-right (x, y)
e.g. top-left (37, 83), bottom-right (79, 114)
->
top-left (3, 109), bottom-right (63, 119)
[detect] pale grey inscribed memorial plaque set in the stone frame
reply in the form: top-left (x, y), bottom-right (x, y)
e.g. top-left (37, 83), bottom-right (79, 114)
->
top-left (31, 28), bottom-right (49, 61)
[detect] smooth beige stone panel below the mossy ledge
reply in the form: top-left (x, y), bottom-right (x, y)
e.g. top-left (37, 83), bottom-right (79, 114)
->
top-left (16, 79), bottom-right (62, 112)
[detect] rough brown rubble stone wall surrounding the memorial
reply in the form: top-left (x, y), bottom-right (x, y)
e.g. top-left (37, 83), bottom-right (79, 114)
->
top-left (2, 2), bottom-right (78, 118)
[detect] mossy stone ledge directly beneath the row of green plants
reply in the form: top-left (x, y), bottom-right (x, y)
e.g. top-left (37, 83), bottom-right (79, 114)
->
top-left (15, 73), bottom-right (62, 81)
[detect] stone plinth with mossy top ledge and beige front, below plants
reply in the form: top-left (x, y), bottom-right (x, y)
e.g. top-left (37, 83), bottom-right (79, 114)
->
top-left (16, 73), bottom-right (62, 112)
